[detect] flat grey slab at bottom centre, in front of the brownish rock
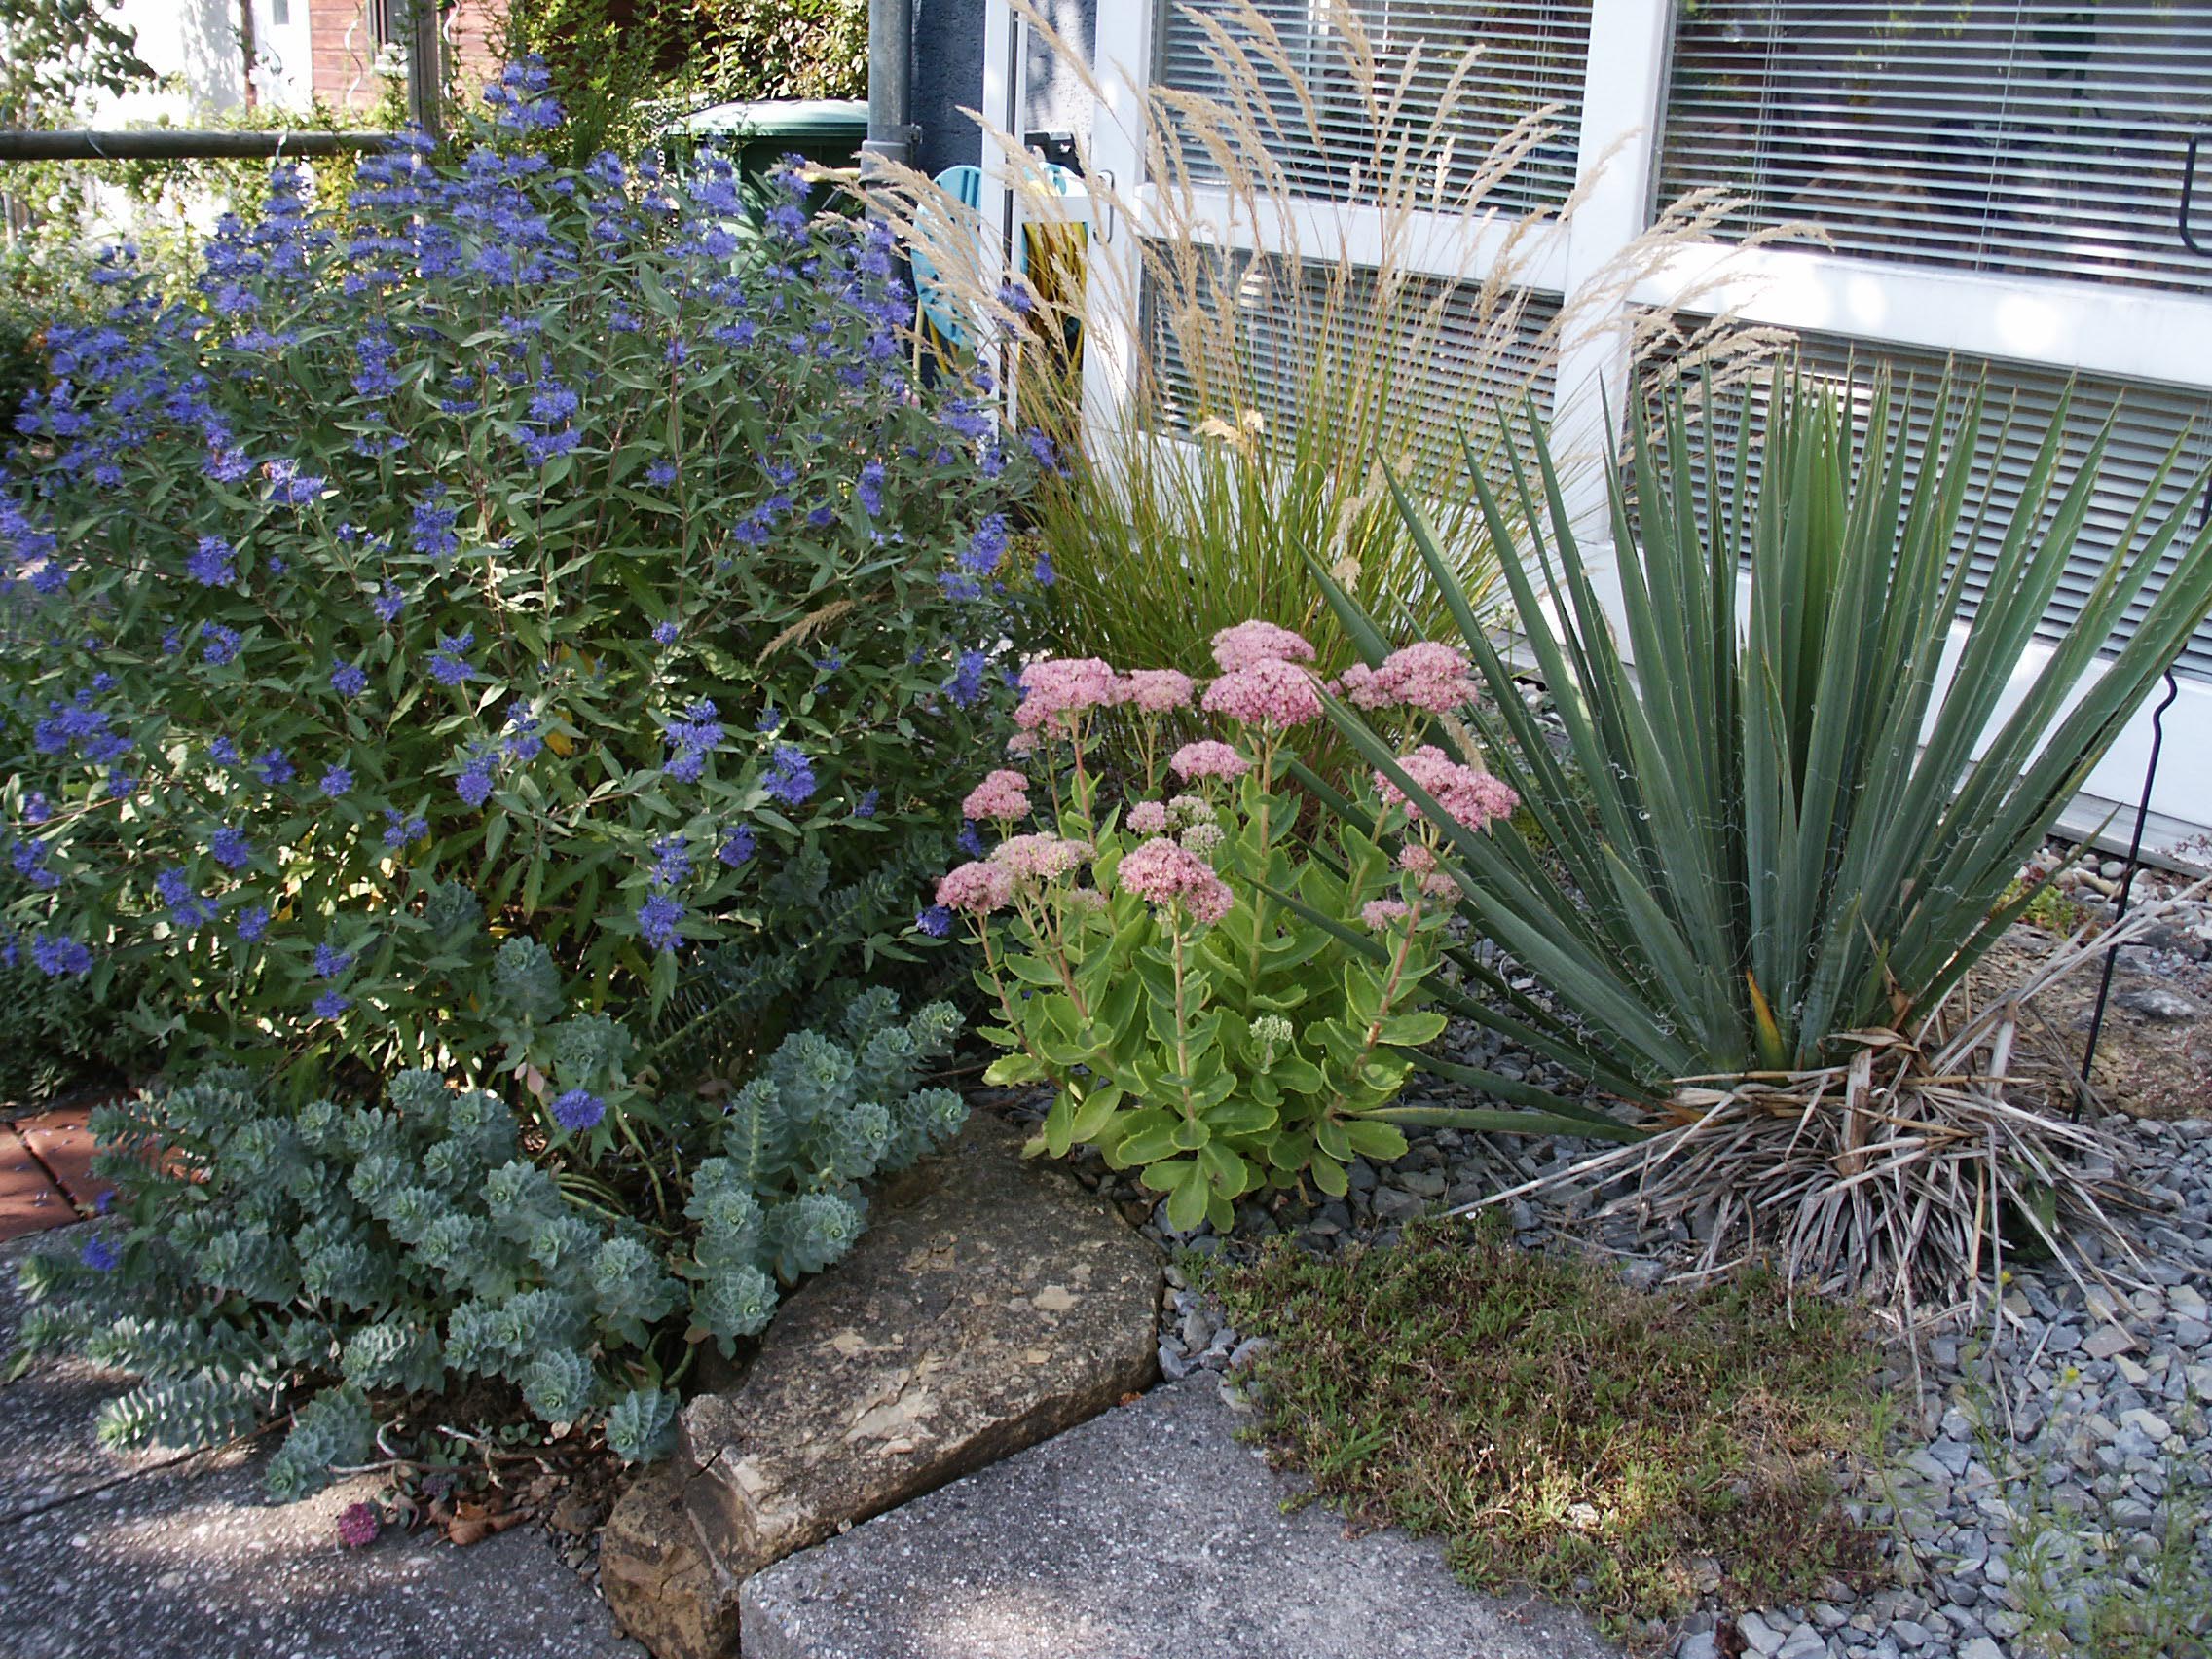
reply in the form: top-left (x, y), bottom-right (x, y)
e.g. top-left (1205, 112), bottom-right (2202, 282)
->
top-left (741, 1378), bottom-right (1619, 1659)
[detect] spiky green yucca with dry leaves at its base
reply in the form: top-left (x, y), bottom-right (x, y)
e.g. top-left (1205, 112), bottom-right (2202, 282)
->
top-left (1316, 372), bottom-right (2212, 1318)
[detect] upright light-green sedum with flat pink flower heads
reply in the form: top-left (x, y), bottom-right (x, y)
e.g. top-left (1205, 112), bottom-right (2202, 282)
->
top-left (938, 621), bottom-right (1628, 1230)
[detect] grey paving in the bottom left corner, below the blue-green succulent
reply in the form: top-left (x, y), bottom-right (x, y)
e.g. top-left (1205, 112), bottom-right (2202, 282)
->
top-left (0, 1241), bottom-right (644, 1659)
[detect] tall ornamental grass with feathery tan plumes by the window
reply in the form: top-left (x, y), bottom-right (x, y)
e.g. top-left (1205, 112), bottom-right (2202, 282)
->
top-left (867, 0), bottom-right (1774, 725)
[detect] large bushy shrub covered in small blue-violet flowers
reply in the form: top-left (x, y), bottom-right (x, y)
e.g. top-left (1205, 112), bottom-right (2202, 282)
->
top-left (0, 68), bottom-right (1038, 1106)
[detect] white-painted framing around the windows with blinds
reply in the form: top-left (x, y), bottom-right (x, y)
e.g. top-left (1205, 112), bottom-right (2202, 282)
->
top-left (1009, 0), bottom-right (2212, 852)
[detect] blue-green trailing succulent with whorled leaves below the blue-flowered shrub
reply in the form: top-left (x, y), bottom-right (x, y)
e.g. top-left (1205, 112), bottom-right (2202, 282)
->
top-left (22, 989), bottom-right (967, 1499)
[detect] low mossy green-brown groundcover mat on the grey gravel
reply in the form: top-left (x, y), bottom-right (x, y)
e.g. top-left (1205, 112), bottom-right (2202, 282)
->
top-left (1212, 1221), bottom-right (1878, 1643)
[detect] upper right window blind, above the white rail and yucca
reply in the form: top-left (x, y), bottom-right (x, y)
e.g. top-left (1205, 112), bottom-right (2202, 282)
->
top-left (1659, 0), bottom-right (2212, 294)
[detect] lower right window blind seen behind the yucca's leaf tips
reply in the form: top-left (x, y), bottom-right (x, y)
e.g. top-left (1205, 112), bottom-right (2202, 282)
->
top-left (1637, 334), bottom-right (2212, 682)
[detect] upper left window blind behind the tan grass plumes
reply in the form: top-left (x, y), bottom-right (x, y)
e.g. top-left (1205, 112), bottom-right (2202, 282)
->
top-left (1153, 0), bottom-right (1591, 212)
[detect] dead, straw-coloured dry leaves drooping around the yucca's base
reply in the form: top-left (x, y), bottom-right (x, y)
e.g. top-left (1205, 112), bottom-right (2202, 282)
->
top-left (1466, 883), bottom-right (2207, 1329)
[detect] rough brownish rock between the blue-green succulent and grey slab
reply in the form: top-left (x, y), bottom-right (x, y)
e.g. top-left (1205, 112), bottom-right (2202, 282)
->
top-left (600, 1113), bottom-right (1160, 1659)
